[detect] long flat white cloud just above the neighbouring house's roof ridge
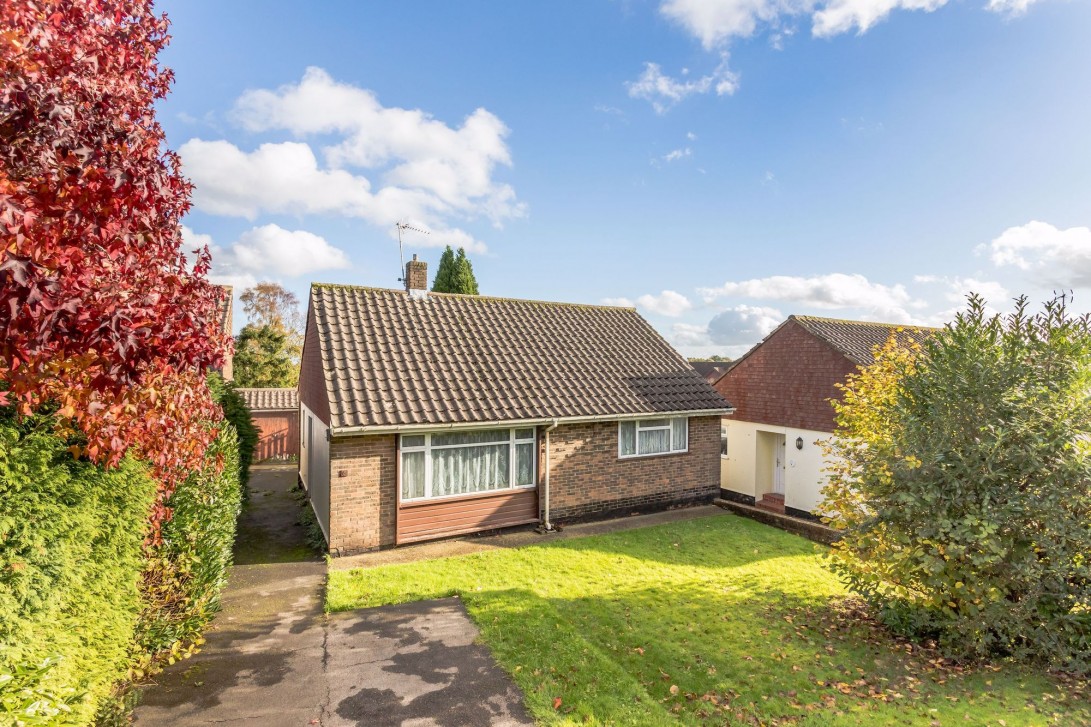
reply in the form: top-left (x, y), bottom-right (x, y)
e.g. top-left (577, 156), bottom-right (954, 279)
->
top-left (698, 273), bottom-right (915, 323)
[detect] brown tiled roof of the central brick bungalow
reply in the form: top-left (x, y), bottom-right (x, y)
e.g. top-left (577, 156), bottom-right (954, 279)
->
top-left (310, 285), bottom-right (730, 429)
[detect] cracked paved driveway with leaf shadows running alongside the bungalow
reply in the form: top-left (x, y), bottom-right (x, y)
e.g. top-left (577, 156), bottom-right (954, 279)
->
top-left (135, 467), bottom-right (532, 727)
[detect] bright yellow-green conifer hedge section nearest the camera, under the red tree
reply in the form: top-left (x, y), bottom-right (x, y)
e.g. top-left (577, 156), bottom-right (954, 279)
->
top-left (0, 418), bottom-right (155, 724)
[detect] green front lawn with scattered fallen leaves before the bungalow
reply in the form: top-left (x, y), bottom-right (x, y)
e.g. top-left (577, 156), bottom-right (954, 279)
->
top-left (327, 514), bottom-right (1091, 727)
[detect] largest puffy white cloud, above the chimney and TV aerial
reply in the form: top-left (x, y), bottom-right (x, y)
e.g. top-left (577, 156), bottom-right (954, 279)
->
top-left (179, 68), bottom-right (526, 251)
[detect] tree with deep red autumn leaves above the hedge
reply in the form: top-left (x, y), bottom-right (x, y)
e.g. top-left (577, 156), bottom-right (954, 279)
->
top-left (0, 0), bottom-right (229, 537)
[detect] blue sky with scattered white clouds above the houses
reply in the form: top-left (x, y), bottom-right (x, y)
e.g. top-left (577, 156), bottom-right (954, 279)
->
top-left (159, 0), bottom-right (1091, 356)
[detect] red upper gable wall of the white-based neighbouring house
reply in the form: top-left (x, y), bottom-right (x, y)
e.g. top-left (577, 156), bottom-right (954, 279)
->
top-left (716, 321), bottom-right (856, 431)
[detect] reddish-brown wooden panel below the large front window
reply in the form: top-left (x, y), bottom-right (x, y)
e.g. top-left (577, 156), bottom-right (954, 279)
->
top-left (397, 489), bottom-right (538, 545)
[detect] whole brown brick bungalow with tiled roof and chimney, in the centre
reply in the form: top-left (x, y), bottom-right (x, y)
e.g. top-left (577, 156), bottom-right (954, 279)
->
top-left (299, 258), bottom-right (731, 553)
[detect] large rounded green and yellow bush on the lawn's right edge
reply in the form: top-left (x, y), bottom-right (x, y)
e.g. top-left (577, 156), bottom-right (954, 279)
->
top-left (824, 296), bottom-right (1091, 671)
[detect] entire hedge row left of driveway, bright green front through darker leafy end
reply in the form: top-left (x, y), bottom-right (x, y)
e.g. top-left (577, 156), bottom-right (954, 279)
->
top-left (0, 385), bottom-right (245, 726)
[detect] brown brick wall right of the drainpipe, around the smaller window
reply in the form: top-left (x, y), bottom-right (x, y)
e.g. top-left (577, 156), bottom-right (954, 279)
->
top-left (539, 417), bottom-right (720, 523)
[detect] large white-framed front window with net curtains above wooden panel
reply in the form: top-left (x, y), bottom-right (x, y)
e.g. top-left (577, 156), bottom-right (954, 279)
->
top-left (401, 427), bottom-right (536, 501)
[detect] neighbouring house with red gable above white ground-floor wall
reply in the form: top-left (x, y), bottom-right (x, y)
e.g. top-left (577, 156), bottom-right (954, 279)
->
top-left (715, 315), bottom-right (933, 516)
